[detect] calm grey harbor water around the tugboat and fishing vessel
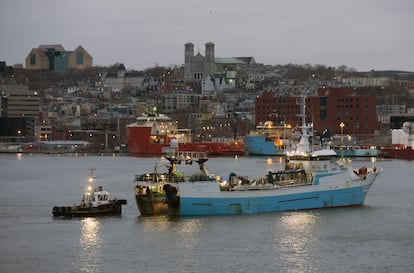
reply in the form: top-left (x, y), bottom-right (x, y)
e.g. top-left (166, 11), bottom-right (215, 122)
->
top-left (0, 154), bottom-right (414, 273)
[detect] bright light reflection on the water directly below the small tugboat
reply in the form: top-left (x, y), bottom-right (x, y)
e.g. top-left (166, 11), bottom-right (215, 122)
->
top-left (79, 218), bottom-right (102, 272)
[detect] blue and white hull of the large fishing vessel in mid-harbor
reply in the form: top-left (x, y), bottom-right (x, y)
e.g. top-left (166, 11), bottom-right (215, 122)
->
top-left (167, 171), bottom-right (380, 216)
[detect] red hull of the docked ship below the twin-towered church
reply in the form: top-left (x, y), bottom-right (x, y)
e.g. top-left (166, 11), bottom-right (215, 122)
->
top-left (127, 126), bottom-right (244, 156)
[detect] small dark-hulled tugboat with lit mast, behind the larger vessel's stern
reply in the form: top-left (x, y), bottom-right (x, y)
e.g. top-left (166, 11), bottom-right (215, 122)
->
top-left (52, 167), bottom-right (127, 217)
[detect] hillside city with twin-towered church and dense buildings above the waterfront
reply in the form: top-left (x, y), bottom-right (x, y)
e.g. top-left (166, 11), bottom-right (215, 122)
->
top-left (0, 42), bottom-right (414, 152)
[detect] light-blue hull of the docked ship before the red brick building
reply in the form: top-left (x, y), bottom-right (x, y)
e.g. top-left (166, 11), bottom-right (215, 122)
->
top-left (244, 136), bottom-right (286, 156)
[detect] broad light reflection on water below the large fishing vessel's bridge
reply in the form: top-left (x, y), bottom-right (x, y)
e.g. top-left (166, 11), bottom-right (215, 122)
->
top-left (274, 212), bottom-right (319, 272)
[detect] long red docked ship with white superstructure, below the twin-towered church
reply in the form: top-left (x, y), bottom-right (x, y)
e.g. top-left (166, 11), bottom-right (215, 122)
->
top-left (126, 114), bottom-right (244, 156)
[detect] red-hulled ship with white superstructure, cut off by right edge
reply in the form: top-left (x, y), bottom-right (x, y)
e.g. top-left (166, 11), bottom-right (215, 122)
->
top-left (381, 122), bottom-right (414, 159)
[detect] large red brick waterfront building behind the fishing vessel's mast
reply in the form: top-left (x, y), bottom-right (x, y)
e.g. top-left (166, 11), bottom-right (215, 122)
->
top-left (255, 87), bottom-right (380, 138)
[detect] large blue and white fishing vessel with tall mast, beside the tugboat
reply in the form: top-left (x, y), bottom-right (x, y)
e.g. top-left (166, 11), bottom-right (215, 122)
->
top-left (138, 95), bottom-right (383, 216)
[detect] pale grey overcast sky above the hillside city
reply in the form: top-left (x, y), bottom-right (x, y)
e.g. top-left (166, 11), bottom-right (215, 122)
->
top-left (0, 0), bottom-right (414, 71)
